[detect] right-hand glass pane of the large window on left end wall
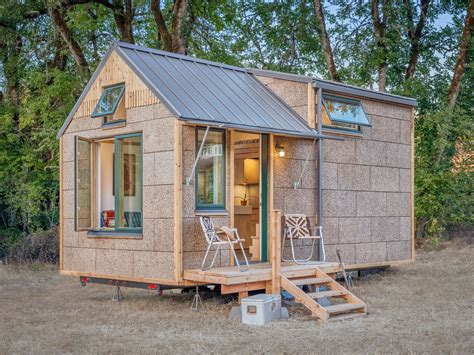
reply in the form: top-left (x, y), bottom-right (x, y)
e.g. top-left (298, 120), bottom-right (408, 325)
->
top-left (115, 136), bottom-right (143, 229)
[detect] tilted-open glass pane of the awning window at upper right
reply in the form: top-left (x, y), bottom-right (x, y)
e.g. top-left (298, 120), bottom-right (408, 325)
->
top-left (323, 96), bottom-right (370, 126)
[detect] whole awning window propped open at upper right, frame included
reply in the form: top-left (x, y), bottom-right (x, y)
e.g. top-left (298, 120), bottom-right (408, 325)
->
top-left (323, 95), bottom-right (372, 134)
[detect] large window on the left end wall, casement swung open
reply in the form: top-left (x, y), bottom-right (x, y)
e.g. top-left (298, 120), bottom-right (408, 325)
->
top-left (74, 133), bottom-right (143, 236)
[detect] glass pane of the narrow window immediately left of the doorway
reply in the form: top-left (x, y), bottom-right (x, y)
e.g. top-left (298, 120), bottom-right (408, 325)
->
top-left (196, 128), bottom-right (225, 207)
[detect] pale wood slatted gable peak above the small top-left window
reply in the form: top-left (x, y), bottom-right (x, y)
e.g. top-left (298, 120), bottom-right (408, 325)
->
top-left (74, 51), bottom-right (159, 118)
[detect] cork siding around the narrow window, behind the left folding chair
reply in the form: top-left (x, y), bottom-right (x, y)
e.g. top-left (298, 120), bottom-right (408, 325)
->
top-left (183, 125), bottom-right (231, 269)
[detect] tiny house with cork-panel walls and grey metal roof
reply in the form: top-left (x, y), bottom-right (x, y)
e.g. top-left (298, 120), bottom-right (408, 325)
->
top-left (58, 43), bottom-right (416, 322)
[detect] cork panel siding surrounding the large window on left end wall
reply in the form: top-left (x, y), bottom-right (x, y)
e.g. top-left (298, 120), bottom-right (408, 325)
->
top-left (62, 103), bottom-right (176, 280)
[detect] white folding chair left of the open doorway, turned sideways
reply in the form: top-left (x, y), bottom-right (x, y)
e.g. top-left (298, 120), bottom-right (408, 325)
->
top-left (199, 216), bottom-right (250, 271)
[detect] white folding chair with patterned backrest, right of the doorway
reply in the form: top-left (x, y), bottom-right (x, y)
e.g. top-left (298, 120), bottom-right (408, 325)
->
top-left (281, 214), bottom-right (326, 264)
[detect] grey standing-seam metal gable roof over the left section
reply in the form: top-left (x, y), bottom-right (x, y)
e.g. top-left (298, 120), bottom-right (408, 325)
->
top-left (58, 42), bottom-right (321, 138)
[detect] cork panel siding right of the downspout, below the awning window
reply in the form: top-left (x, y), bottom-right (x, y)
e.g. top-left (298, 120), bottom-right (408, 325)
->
top-left (323, 100), bottom-right (412, 264)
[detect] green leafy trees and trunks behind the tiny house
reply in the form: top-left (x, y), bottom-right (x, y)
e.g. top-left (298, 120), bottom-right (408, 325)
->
top-left (0, 0), bottom-right (474, 256)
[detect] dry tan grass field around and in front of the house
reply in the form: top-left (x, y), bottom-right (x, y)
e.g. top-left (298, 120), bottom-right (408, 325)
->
top-left (0, 238), bottom-right (474, 354)
